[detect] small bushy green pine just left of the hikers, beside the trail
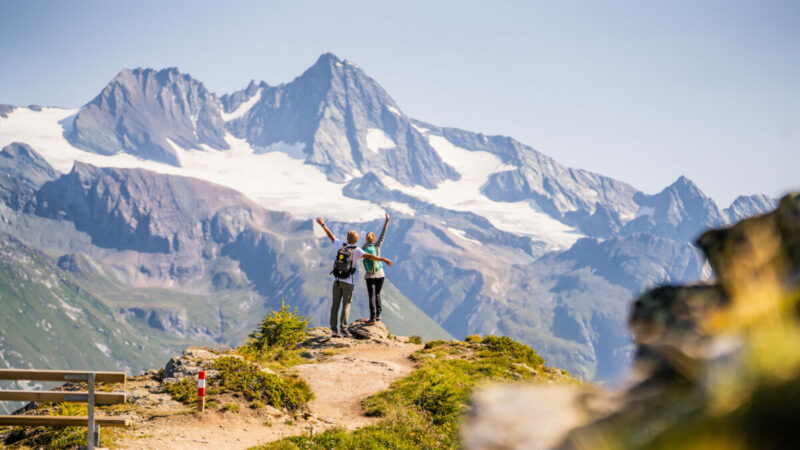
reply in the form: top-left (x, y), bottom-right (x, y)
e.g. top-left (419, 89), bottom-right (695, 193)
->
top-left (247, 300), bottom-right (309, 352)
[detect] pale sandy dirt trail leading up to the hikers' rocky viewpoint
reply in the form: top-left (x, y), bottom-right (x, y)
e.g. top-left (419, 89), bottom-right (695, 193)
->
top-left (117, 344), bottom-right (421, 450)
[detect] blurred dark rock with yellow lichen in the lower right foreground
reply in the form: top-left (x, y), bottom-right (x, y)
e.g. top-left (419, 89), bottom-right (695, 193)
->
top-left (463, 194), bottom-right (800, 449)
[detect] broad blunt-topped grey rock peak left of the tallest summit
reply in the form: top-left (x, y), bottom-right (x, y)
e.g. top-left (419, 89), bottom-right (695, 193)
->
top-left (68, 68), bottom-right (228, 166)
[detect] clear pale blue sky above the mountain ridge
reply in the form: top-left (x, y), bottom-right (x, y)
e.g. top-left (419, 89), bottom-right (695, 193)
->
top-left (0, 0), bottom-right (800, 206)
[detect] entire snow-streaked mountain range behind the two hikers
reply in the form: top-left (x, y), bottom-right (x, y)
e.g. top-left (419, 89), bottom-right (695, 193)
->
top-left (0, 54), bottom-right (775, 379)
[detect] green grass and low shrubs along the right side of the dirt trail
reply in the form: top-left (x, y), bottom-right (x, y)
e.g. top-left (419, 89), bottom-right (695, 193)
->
top-left (255, 336), bottom-right (577, 449)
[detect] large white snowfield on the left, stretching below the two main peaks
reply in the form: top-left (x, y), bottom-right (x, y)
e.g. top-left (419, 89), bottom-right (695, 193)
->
top-left (0, 108), bottom-right (383, 221)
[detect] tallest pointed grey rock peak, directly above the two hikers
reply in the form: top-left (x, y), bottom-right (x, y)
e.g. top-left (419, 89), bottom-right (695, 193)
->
top-left (228, 53), bottom-right (458, 187)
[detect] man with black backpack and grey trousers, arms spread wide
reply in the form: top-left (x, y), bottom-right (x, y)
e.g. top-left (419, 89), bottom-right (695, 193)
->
top-left (317, 217), bottom-right (393, 337)
